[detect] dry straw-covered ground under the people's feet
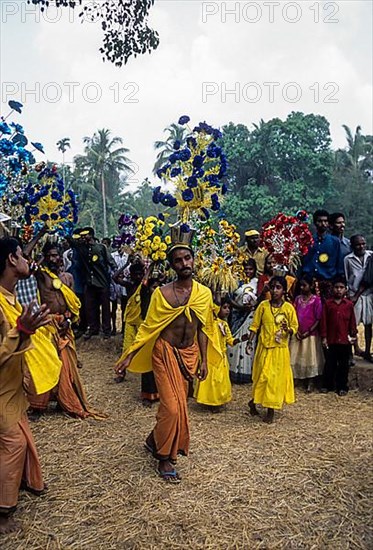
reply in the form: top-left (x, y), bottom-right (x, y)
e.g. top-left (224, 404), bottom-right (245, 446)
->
top-left (1, 340), bottom-right (373, 550)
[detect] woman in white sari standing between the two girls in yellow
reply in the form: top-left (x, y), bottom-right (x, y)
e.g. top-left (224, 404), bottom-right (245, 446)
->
top-left (228, 258), bottom-right (258, 384)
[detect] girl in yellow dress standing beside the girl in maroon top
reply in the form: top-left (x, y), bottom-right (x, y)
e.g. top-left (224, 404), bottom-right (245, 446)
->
top-left (248, 276), bottom-right (298, 423)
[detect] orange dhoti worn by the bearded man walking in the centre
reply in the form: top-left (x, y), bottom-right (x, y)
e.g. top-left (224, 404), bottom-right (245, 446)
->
top-left (153, 338), bottom-right (199, 460)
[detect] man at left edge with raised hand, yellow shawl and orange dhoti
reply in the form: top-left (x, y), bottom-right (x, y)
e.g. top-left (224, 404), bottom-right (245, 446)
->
top-left (0, 237), bottom-right (53, 535)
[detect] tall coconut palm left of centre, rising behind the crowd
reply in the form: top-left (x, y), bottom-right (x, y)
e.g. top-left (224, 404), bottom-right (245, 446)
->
top-left (74, 128), bottom-right (133, 237)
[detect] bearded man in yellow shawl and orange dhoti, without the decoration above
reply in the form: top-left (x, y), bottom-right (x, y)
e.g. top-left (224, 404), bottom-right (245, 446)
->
top-left (116, 244), bottom-right (221, 483)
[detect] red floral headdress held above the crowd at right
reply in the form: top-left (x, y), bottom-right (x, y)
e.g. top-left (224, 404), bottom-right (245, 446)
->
top-left (262, 210), bottom-right (313, 269)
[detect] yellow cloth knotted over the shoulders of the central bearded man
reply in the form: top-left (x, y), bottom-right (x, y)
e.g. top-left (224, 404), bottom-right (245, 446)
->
top-left (119, 281), bottom-right (222, 373)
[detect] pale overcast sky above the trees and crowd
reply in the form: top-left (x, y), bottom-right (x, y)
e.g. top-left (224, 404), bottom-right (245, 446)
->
top-left (0, 0), bottom-right (372, 186)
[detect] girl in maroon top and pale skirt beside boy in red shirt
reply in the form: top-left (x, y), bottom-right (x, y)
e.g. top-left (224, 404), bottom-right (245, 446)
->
top-left (290, 274), bottom-right (324, 392)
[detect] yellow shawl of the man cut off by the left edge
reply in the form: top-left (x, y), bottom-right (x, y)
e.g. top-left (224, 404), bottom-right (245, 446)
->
top-left (0, 292), bottom-right (62, 394)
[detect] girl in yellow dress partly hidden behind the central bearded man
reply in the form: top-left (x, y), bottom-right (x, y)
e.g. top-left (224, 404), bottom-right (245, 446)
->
top-left (194, 298), bottom-right (248, 412)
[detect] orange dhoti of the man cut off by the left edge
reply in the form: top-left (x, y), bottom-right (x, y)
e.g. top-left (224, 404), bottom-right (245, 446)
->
top-left (0, 415), bottom-right (44, 514)
